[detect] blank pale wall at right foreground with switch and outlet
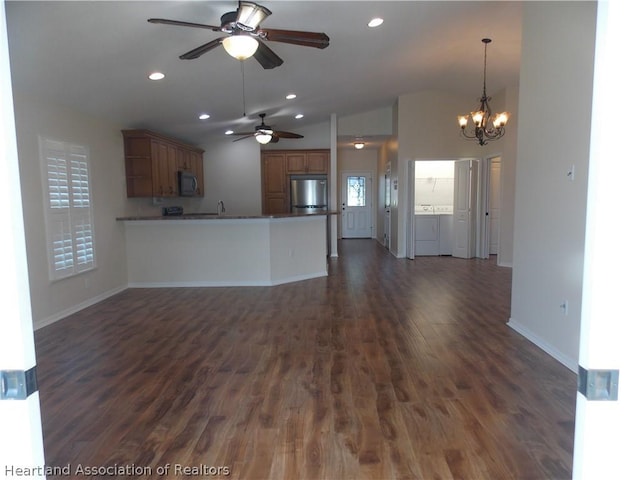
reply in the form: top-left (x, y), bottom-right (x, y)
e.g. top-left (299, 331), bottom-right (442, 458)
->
top-left (509, 2), bottom-right (596, 370)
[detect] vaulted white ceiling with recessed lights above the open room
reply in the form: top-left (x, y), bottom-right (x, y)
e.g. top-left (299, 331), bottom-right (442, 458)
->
top-left (6, 1), bottom-right (522, 148)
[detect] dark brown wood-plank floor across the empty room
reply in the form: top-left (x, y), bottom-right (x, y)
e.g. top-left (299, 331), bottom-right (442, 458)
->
top-left (36, 240), bottom-right (576, 480)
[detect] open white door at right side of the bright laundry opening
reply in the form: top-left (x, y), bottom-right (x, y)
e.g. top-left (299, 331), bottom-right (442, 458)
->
top-left (451, 160), bottom-right (478, 258)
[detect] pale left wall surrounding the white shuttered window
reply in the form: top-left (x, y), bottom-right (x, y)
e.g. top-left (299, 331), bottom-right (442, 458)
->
top-left (14, 91), bottom-right (128, 327)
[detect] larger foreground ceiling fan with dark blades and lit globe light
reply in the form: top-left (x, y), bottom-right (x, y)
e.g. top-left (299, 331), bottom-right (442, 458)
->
top-left (148, 0), bottom-right (329, 69)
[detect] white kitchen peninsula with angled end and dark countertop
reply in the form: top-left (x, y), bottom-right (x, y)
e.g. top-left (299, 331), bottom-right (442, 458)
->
top-left (117, 212), bottom-right (333, 287)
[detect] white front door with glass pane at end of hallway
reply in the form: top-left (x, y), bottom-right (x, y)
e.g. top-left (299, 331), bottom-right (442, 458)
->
top-left (342, 172), bottom-right (373, 238)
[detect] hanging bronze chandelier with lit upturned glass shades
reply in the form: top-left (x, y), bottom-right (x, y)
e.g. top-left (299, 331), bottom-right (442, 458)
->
top-left (458, 38), bottom-right (509, 145)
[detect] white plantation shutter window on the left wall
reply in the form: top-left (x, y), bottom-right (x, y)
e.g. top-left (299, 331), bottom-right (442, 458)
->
top-left (40, 138), bottom-right (95, 280)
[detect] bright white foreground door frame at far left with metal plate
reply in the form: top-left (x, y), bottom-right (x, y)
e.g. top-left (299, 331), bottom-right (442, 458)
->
top-left (0, 2), bottom-right (45, 468)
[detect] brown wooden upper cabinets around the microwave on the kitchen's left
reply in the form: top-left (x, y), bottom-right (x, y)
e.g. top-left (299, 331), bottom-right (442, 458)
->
top-left (122, 130), bottom-right (204, 197)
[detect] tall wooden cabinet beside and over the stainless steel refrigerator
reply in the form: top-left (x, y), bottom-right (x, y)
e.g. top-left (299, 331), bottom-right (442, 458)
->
top-left (261, 150), bottom-right (329, 215)
